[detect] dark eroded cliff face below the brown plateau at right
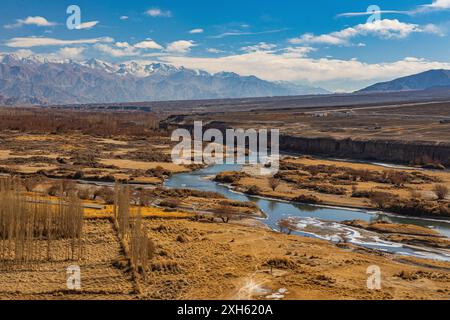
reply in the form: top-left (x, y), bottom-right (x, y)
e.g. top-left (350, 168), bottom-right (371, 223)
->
top-left (280, 135), bottom-right (450, 167)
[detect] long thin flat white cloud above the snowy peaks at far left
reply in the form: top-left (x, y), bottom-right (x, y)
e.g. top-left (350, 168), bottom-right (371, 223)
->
top-left (5, 37), bottom-right (114, 48)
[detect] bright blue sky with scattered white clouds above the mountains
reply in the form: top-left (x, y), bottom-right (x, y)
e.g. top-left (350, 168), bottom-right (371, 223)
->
top-left (0, 0), bottom-right (450, 91)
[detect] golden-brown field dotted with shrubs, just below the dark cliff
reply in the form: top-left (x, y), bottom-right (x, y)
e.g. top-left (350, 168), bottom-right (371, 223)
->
top-left (221, 157), bottom-right (450, 208)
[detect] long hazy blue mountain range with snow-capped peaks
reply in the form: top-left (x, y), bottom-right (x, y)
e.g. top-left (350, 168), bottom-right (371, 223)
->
top-left (0, 54), bottom-right (330, 105)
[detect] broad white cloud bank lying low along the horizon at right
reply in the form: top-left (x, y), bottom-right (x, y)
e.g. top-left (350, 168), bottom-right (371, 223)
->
top-left (160, 49), bottom-right (450, 90)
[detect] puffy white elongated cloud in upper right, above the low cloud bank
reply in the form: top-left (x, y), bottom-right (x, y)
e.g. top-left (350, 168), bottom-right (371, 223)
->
top-left (289, 19), bottom-right (442, 45)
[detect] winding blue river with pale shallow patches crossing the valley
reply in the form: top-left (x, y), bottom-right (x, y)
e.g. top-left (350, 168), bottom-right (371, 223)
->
top-left (165, 164), bottom-right (450, 261)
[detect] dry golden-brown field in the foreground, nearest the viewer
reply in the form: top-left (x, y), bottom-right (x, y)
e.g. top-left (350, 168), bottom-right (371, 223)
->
top-left (0, 219), bottom-right (450, 299)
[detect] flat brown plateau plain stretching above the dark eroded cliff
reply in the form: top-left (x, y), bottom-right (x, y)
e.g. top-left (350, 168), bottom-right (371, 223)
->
top-left (163, 102), bottom-right (450, 143)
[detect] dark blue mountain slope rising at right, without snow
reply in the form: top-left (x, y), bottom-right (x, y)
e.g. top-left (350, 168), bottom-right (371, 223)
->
top-left (359, 70), bottom-right (450, 92)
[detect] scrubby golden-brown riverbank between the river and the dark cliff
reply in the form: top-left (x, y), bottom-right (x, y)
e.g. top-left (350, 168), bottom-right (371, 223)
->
top-left (215, 157), bottom-right (450, 218)
